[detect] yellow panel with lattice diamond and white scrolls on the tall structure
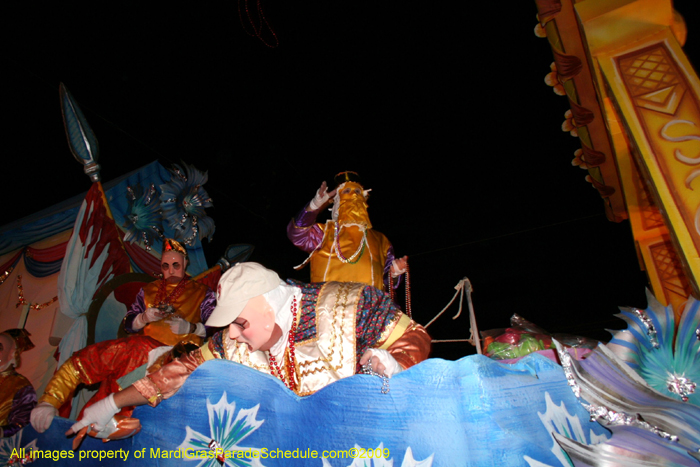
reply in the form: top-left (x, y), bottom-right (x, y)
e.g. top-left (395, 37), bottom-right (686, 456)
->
top-left (597, 33), bottom-right (700, 296)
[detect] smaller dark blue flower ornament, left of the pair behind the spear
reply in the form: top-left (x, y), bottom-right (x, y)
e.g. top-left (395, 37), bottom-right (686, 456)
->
top-left (124, 184), bottom-right (163, 251)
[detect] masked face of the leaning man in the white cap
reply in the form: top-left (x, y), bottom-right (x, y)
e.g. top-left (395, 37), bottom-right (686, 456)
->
top-left (228, 295), bottom-right (279, 352)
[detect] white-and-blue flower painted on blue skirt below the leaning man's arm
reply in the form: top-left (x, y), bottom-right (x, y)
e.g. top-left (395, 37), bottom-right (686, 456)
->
top-left (177, 392), bottom-right (265, 467)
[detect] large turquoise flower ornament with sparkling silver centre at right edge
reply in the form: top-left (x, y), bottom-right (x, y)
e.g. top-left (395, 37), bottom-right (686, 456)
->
top-left (607, 290), bottom-right (700, 406)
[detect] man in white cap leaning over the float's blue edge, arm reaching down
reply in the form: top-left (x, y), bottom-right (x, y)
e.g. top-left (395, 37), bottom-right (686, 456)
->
top-left (67, 263), bottom-right (430, 437)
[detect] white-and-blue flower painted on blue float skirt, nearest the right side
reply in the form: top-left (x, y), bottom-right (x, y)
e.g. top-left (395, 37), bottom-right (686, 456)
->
top-left (523, 391), bottom-right (608, 467)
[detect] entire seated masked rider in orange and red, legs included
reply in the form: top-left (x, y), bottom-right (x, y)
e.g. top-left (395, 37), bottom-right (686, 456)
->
top-left (31, 239), bottom-right (216, 433)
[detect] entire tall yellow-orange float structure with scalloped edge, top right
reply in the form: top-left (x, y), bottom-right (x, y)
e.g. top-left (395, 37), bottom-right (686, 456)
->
top-left (535, 0), bottom-right (700, 322)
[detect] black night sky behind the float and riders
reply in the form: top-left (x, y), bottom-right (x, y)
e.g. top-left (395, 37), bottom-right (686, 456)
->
top-left (2, 0), bottom-right (700, 358)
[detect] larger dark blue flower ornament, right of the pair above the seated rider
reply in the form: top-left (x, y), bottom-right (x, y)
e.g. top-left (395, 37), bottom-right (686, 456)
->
top-left (160, 163), bottom-right (215, 246)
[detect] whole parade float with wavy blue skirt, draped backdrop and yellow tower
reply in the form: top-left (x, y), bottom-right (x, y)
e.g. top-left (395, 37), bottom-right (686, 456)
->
top-left (0, 0), bottom-right (700, 467)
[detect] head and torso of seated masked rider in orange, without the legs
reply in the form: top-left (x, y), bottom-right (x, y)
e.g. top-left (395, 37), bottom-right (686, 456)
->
top-left (124, 239), bottom-right (216, 345)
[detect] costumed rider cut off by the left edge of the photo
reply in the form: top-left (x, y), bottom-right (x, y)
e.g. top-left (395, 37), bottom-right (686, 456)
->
top-left (0, 329), bottom-right (36, 438)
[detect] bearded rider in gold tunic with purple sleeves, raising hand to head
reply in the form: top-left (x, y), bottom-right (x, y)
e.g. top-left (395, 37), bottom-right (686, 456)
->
top-left (287, 172), bottom-right (408, 290)
